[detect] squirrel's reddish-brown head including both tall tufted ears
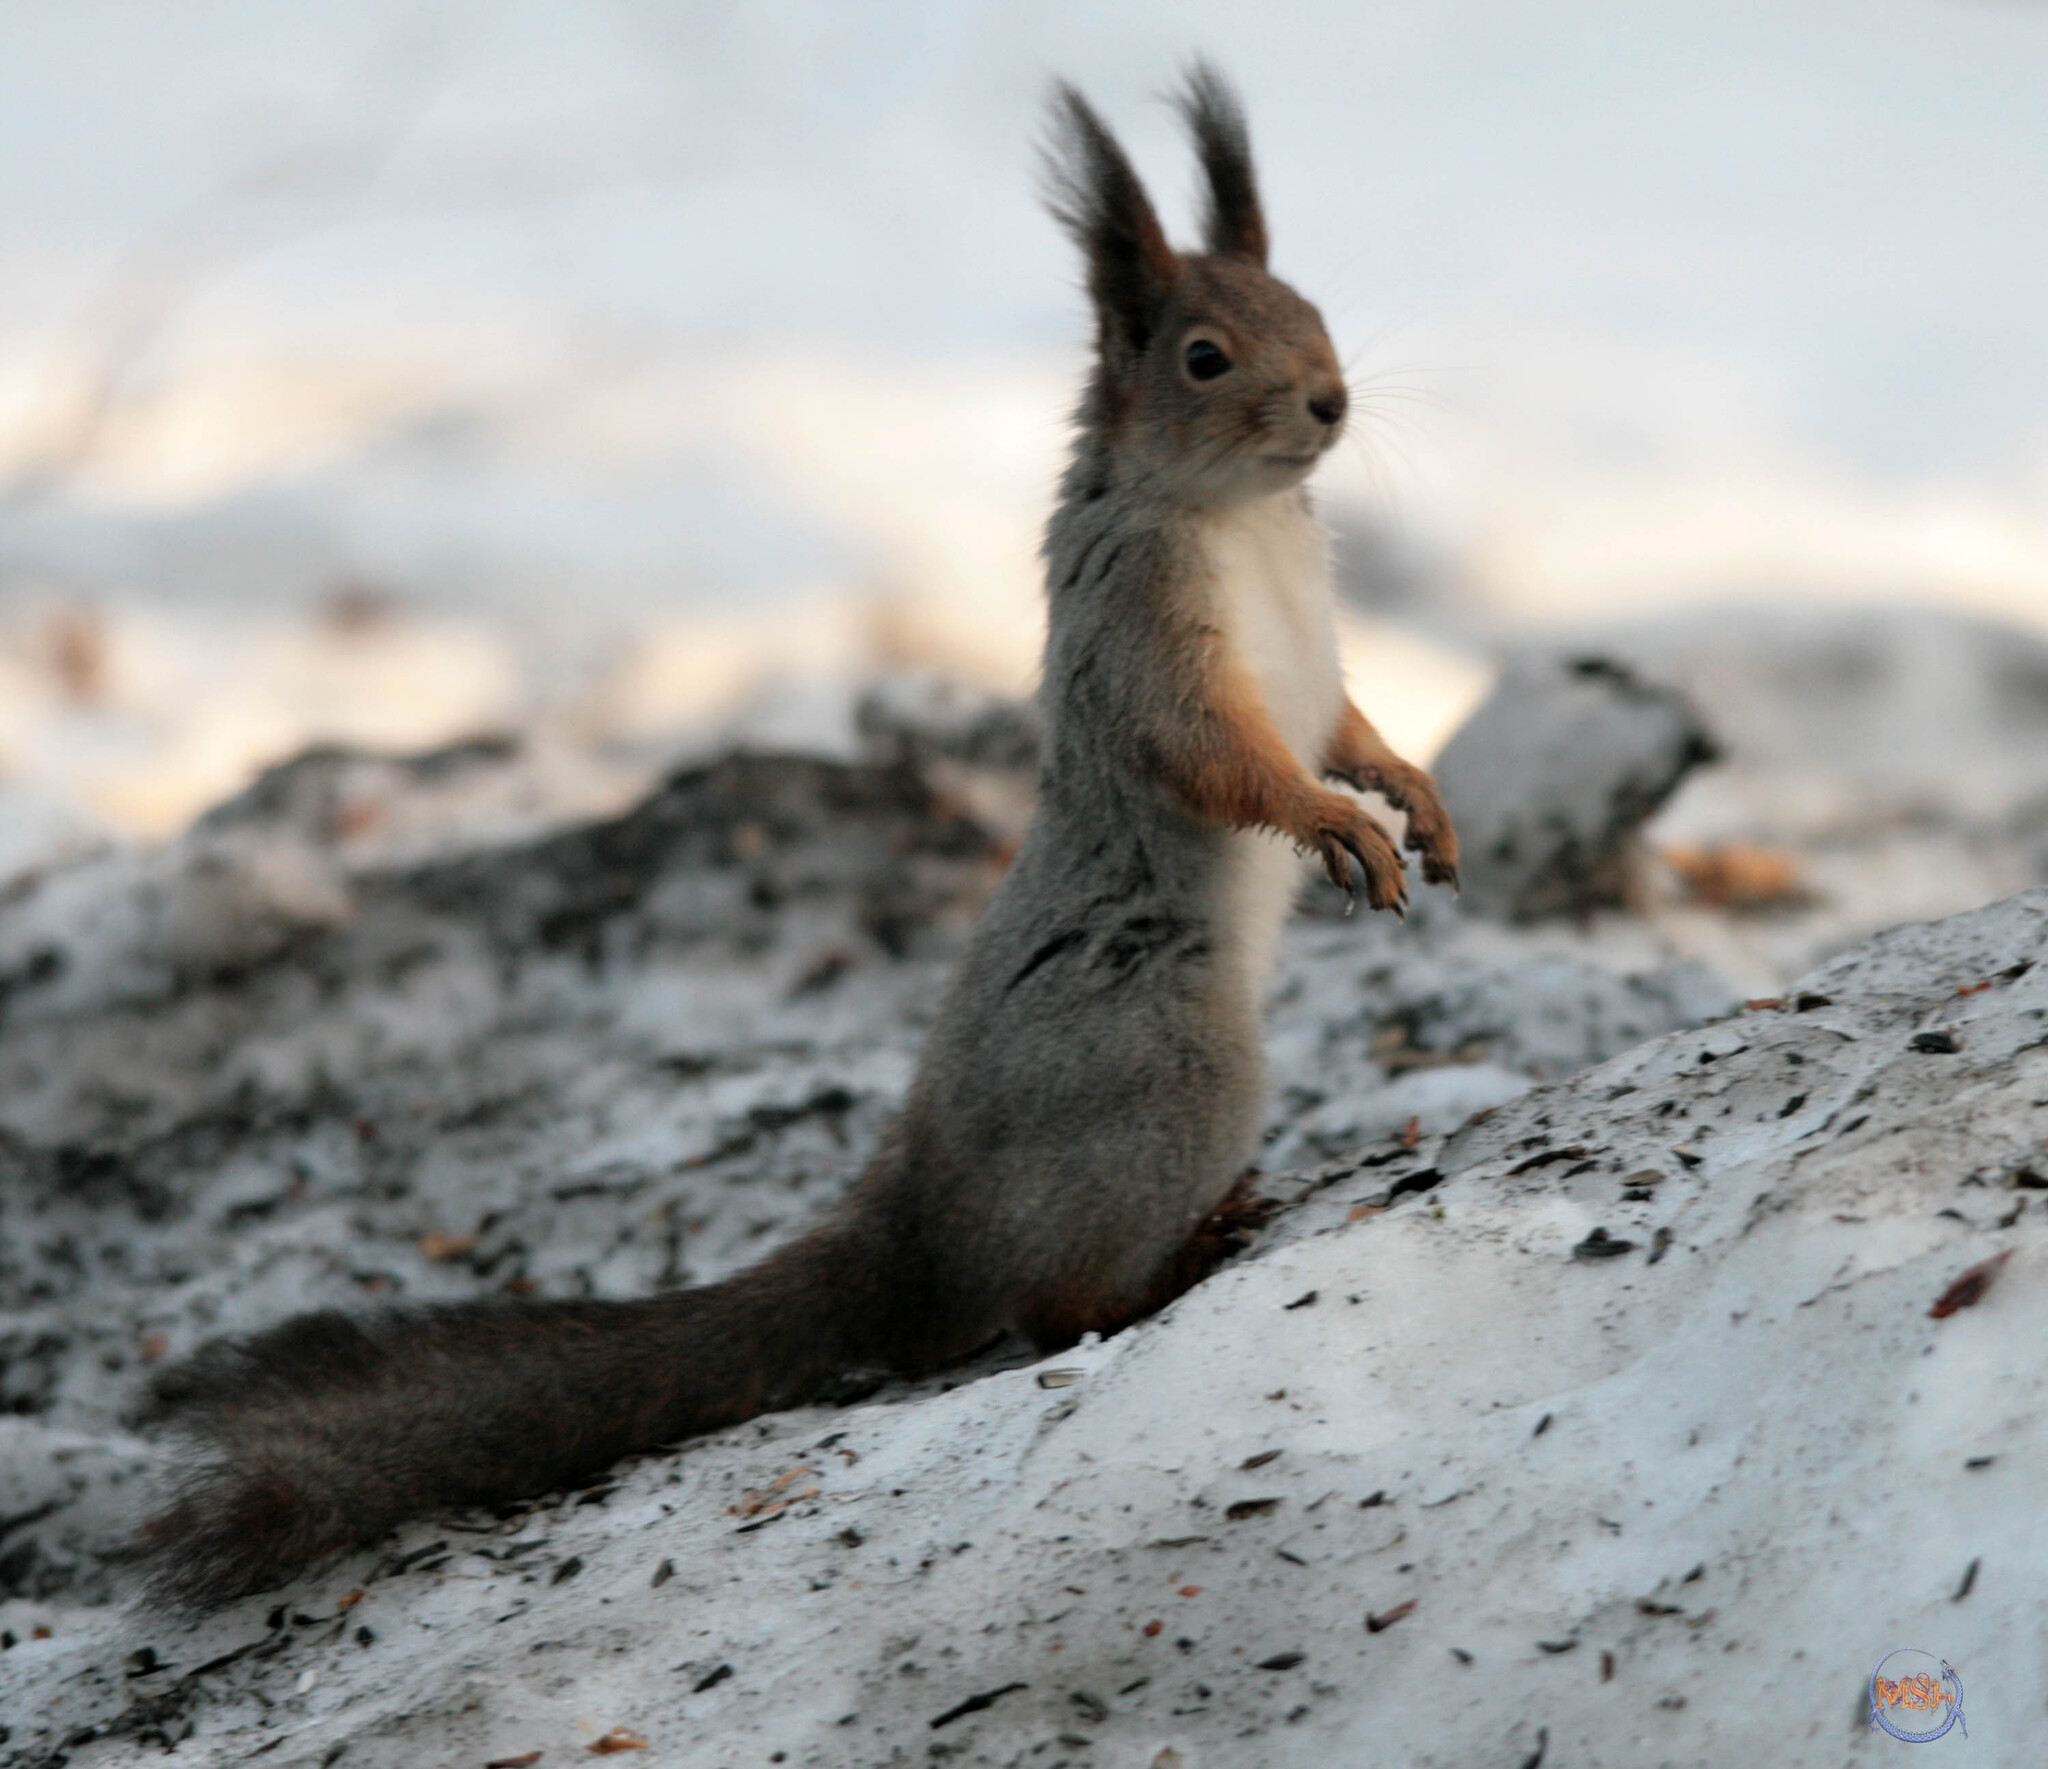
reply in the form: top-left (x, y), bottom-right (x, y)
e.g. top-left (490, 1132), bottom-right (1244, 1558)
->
top-left (1044, 61), bottom-right (1350, 508)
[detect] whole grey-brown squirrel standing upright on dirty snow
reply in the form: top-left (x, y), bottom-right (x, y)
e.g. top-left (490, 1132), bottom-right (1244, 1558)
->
top-left (135, 63), bottom-right (1458, 1609)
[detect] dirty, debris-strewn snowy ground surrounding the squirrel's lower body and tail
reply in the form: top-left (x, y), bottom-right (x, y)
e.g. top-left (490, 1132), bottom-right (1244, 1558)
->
top-left (0, 741), bottom-right (2048, 1769)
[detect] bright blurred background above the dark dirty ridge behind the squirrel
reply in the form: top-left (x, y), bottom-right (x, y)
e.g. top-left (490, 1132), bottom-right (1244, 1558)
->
top-left (0, 0), bottom-right (2048, 909)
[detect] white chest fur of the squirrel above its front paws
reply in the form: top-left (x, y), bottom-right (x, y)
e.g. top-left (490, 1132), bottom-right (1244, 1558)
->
top-left (1202, 491), bottom-right (1343, 774)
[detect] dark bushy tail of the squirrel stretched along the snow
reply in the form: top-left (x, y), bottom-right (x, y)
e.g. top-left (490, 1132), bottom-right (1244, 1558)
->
top-left (137, 1220), bottom-right (893, 1609)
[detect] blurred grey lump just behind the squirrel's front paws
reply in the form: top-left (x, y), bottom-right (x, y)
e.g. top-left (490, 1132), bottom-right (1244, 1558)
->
top-left (1436, 655), bottom-right (1718, 921)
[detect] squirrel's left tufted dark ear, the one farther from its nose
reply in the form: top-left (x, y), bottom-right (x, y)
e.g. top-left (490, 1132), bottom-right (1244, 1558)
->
top-left (1044, 80), bottom-right (1180, 356)
